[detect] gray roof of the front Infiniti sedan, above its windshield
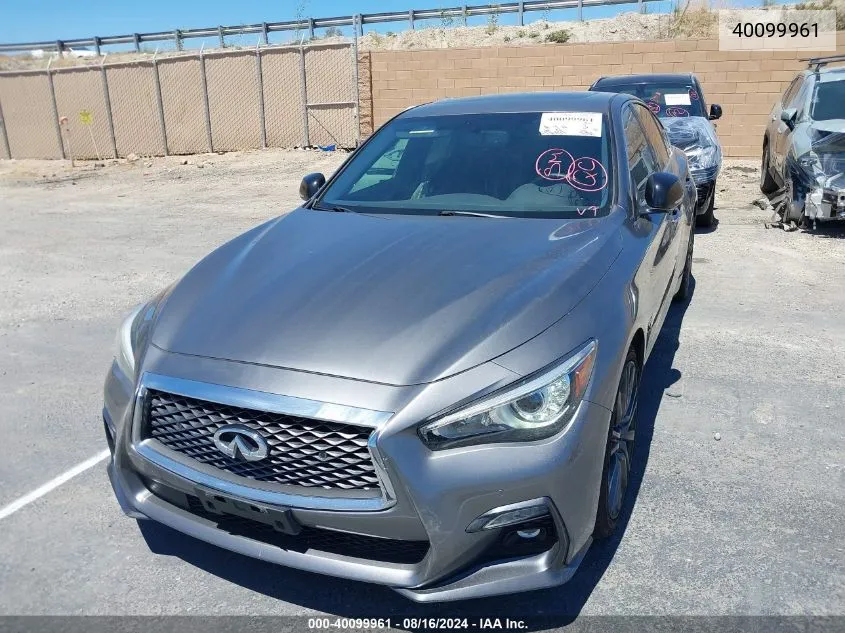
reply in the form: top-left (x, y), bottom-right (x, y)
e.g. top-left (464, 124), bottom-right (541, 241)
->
top-left (400, 92), bottom-right (620, 118)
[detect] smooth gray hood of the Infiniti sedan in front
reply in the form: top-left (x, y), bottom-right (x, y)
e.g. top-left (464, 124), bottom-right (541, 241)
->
top-left (152, 209), bottom-right (624, 385)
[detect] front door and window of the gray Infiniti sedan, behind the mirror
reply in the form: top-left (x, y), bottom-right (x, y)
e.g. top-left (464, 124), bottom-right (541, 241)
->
top-left (622, 103), bottom-right (681, 347)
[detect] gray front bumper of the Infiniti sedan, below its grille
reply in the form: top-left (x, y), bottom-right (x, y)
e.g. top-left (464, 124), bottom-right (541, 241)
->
top-left (104, 350), bottom-right (610, 602)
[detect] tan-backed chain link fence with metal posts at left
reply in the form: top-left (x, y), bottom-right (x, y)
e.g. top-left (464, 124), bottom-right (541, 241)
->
top-left (0, 43), bottom-right (360, 160)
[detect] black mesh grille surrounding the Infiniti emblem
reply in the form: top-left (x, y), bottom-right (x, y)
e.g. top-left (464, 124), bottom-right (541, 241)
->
top-left (141, 389), bottom-right (379, 490)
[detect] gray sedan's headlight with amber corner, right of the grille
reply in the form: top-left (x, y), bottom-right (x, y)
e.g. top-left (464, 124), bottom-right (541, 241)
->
top-left (419, 341), bottom-right (596, 450)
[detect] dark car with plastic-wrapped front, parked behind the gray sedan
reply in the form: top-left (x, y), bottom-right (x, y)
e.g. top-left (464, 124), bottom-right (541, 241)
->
top-left (590, 73), bottom-right (722, 226)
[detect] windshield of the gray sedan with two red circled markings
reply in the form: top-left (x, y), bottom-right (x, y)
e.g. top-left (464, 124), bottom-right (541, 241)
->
top-left (315, 112), bottom-right (613, 218)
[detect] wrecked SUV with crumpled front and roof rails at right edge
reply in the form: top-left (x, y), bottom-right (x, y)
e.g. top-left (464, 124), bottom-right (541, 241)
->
top-left (760, 55), bottom-right (845, 227)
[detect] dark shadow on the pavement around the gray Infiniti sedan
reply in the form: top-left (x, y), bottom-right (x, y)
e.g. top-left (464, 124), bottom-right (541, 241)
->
top-left (139, 288), bottom-right (695, 630)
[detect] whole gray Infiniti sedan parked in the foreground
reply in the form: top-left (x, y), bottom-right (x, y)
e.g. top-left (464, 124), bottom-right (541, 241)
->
top-left (103, 92), bottom-right (696, 602)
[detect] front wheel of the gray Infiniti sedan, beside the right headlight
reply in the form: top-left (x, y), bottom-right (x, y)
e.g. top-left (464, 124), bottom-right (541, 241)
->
top-left (593, 347), bottom-right (641, 539)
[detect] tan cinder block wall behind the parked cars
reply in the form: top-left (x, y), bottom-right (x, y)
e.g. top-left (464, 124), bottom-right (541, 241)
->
top-left (370, 32), bottom-right (845, 158)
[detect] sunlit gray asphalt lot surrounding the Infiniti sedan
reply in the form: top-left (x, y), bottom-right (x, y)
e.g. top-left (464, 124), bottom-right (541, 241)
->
top-left (0, 151), bottom-right (845, 624)
